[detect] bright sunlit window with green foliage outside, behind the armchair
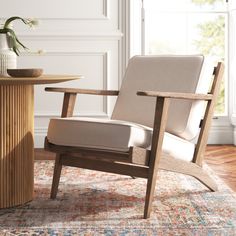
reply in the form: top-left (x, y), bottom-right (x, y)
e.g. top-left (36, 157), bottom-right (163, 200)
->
top-left (142, 0), bottom-right (228, 116)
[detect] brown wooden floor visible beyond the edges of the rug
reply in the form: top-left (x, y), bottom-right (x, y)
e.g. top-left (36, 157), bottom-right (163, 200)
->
top-left (35, 145), bottom-right (236, 191)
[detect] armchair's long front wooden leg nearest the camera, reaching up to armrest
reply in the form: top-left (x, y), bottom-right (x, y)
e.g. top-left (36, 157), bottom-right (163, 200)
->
top-left (144, 97), bottom-right (170, 219)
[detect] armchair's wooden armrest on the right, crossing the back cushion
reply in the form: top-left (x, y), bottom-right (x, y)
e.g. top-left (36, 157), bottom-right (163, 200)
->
top-left (137, 91), bottom-right (213, 100)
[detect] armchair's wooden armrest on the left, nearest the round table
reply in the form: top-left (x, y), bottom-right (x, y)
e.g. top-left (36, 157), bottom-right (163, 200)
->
top-left (45, 87), bottom-right (119, 96)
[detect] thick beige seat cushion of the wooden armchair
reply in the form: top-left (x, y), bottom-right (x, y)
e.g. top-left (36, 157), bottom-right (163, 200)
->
top-left (47, 118), bottom-right (195, 161)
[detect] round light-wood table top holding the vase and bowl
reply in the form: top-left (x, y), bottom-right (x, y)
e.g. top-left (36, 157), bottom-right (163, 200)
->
top-left (0, 75), bottom-right (83, 85)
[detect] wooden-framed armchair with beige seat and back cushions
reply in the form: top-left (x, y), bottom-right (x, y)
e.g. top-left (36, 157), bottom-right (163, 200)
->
top-left (45, 56), bottom-right (223, 218)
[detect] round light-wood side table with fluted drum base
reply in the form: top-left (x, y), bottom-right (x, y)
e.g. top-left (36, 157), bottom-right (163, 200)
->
top-left (0, 75), bottom-right (81, 208)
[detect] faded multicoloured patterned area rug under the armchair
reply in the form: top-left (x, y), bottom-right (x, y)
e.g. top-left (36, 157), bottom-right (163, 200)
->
top-left (0, 161), bottom-right (236, 236)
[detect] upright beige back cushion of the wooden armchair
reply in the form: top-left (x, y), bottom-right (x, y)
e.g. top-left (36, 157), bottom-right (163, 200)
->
top-left (112, 55), bottom-right (213, 140)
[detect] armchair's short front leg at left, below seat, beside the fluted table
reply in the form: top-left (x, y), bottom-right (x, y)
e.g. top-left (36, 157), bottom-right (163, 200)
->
top-left (50, 154), bottom-right (62, 199)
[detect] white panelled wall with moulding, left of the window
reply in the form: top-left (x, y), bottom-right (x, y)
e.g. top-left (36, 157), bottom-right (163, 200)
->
top-left (0, 0), bottom-right (125, 147)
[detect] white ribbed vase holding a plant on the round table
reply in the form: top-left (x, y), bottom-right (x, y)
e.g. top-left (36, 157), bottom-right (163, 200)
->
top-left (0, 33), bottom-right (17, 76)
